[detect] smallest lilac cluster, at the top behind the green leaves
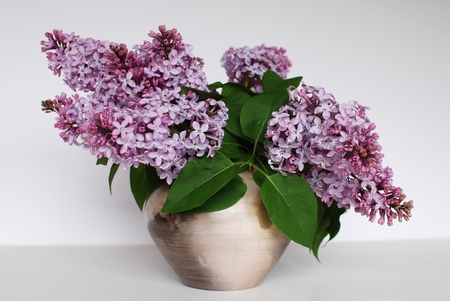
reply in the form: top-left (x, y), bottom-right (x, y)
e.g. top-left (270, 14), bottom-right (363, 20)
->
top-left (221, 44), bottom-right (292, 93)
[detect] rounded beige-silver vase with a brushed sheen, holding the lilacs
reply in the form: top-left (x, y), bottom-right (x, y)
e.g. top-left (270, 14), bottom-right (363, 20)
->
top-left (144, 171), bottom-right (290, 290)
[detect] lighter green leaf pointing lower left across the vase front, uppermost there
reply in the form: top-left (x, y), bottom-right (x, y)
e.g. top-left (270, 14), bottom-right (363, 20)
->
top-left (161, 152), bottom-right (243, 212)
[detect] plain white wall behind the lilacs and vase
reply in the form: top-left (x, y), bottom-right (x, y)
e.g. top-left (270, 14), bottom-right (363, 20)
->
top-left (0, 0), bottom-right (450, 245)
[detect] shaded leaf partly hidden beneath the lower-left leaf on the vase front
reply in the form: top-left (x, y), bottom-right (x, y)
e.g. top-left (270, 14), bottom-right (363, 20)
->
top-left (182, 176), bottom-right (247, 213)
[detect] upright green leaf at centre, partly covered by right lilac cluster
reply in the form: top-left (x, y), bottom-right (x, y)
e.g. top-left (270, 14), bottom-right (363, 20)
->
top-left (241, 91), bottom-right (289, 143)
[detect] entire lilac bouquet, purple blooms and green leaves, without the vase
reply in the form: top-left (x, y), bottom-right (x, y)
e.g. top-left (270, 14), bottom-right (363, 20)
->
top-left (41, 26), bottom-right (413, 256)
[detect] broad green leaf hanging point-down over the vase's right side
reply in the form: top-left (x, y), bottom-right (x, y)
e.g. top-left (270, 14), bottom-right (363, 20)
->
top-left (261, 173), bottom-right (318, 248)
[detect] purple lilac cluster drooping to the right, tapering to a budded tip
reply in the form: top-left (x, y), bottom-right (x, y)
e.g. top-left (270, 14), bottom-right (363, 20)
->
top-left (266, 84), bottom-right (413, 225)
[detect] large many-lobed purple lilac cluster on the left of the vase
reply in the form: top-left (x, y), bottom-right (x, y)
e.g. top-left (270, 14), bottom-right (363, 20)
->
top-left (41, 26), bottom-right (228, 184)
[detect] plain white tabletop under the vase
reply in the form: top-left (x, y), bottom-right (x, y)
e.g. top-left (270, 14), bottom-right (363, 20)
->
top-left (0, 240), bottom-right (450, 301)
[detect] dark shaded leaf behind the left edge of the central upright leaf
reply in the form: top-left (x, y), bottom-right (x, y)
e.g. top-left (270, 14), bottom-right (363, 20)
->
top-left (223, 92), bottom-right (252, 138)
